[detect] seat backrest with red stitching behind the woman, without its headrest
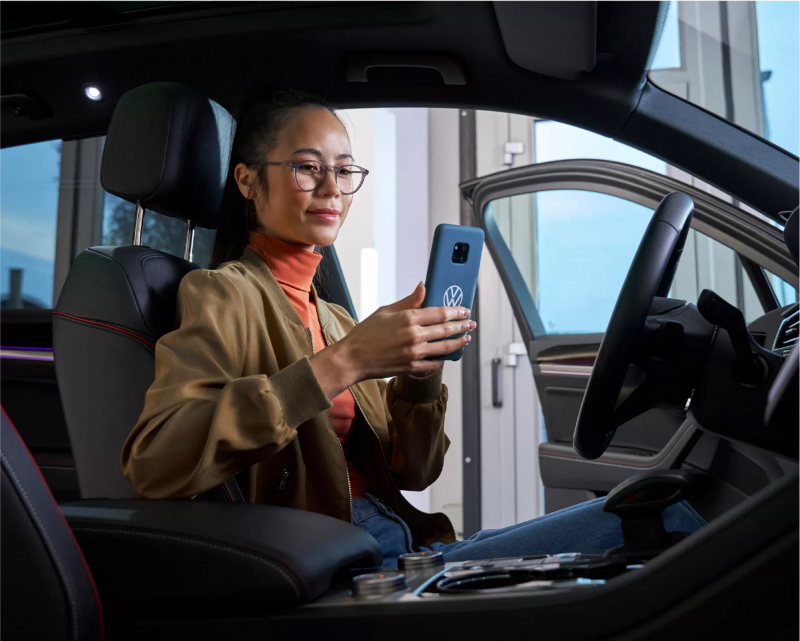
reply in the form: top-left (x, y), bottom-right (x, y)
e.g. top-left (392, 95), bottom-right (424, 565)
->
top-left (53, 246), bottom-right (198, 498)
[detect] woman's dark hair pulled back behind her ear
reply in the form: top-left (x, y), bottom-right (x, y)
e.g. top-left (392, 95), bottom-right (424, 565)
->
top-left (209, 89), bottom-right (344, 269)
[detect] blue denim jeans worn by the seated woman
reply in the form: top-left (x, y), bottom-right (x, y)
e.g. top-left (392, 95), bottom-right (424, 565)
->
top-left (353, 494), bottom-right (706, 567)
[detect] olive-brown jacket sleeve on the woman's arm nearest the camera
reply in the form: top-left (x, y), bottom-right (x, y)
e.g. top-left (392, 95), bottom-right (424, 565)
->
top-left (121, 270), bottom-right (331, 498)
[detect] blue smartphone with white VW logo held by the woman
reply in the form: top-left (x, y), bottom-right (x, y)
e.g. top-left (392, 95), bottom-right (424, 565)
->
top-left (422, 224), bottom-right (483, 361)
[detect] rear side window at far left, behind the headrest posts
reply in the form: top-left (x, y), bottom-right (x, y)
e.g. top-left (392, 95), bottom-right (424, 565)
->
top-left (0, 138), bottom-right (214, 316)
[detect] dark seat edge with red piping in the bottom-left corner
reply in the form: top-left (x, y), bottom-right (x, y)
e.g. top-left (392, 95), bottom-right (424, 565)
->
top-left (0, 411), bottom-right (103, 641)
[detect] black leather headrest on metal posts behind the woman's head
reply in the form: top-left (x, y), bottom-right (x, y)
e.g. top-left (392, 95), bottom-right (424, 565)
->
top-left (100, 82), bottom-right (236, 229)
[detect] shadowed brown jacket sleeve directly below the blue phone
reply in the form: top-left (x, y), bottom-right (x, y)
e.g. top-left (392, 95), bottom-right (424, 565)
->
top-left (378, 369), bottom-right (450, 492)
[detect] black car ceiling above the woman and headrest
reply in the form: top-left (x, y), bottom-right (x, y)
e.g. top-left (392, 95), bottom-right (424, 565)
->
top-left (0, 1), bottom-right (666, 147)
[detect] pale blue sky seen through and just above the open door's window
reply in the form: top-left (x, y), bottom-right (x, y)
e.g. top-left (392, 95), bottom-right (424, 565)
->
top-left (534, 121), bottom-right (666, 334)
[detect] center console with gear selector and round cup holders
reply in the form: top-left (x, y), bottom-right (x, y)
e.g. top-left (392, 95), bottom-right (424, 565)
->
top-left (318, 470), bottom-right (698, 605)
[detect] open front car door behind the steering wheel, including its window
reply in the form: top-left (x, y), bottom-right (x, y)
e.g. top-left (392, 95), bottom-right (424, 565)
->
top-left (461, 160), bottom-right (797, 518)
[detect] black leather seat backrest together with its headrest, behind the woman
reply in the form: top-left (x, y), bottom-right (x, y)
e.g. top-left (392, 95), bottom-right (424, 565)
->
top-left (53, 82), bottom-right (235, 498)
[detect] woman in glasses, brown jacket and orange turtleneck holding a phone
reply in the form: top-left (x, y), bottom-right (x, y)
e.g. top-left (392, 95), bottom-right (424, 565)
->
top-left (122, 92), bottom-right (703, 566)
